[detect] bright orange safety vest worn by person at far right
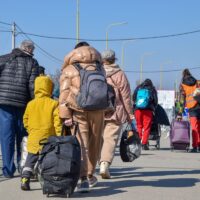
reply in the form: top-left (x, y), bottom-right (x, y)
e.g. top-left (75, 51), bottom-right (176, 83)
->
top-left (181, 84), bottom-right (197, 109)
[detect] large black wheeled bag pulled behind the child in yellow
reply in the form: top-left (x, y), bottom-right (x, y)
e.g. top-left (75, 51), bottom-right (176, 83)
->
top-left (39, 124), bottom-right (81, 197)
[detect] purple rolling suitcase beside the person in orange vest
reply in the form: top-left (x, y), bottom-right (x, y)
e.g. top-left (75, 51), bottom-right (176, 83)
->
top-left (170, 120), bottom-right (190, 151)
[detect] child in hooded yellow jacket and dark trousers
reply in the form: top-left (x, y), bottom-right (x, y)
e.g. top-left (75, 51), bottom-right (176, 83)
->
top-left (21, 76), bottom-right (61, 190)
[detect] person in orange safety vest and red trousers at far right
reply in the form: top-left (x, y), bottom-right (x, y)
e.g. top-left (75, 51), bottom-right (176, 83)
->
top-left (180, 69), bottom-right (200, 153)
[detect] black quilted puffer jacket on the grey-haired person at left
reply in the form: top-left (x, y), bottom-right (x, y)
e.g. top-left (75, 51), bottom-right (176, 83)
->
top-left (0, 48), bottom-right (39, 107)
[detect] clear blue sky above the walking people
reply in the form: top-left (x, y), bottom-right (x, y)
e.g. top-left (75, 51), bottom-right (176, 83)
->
top-left (0, 0), bottom-right (200, 89)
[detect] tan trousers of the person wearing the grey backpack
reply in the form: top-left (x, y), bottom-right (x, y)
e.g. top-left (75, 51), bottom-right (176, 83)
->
top-left (73, 111), bottom-right (104, 177)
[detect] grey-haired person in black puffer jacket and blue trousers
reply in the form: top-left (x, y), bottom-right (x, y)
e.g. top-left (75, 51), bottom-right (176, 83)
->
top-left (0, 40), bottom-right (38, 178)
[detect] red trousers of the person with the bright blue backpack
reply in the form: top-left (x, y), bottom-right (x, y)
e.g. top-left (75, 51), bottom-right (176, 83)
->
top-left (134, 110), bottom-right (153, 144)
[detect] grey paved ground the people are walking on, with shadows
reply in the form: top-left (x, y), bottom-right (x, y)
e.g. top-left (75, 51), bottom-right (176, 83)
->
top-left (0, 135), bottom-right (200, 200)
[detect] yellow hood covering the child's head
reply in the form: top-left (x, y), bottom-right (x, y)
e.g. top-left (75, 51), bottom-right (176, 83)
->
top-left (34, 76), bottom-right (53, 98)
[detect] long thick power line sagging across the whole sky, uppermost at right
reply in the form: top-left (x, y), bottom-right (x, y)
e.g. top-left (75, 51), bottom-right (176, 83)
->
top-left (15, 29), bottom-right (200, 42)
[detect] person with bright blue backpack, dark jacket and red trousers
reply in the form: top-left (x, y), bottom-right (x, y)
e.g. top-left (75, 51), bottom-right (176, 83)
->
top-left (133, 79), bottom-right (158, 150)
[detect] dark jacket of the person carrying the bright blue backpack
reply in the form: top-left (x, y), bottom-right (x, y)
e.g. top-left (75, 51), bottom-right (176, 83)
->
top-left (133, 82), bottom-right (158, 112)
